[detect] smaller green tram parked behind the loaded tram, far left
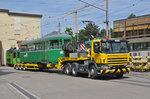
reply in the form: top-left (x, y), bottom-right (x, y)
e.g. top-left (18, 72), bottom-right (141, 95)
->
top-left (6, 48), bottom-right (20, 66)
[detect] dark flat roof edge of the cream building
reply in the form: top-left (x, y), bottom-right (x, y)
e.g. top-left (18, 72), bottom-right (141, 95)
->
top-left (0, 9), bottom-right (42, 17)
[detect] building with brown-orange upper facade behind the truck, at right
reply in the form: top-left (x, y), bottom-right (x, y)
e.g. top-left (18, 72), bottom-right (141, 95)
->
top-left (113, 14), bottom-right (150, 58)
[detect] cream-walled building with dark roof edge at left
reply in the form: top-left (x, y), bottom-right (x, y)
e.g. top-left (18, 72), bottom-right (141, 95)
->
top-left (0, 9), bottom-right (42, 65)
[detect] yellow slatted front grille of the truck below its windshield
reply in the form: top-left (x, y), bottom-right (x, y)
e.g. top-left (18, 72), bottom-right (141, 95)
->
top-left (107, 55), bottom-right (129, 66)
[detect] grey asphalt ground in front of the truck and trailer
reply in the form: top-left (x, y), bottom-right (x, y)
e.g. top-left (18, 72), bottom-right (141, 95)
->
top-left (0, 67), bottom-right (150, 99)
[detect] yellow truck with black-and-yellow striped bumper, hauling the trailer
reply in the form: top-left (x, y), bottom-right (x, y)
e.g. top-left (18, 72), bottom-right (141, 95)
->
top-left (59, 39), bottom-right (130, 79)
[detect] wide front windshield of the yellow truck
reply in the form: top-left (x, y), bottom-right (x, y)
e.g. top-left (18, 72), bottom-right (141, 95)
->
top-left (102, 41), bottom-right (128, 53)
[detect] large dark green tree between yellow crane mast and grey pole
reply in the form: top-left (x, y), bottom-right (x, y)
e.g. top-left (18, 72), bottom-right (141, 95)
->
top-left (79, 22), bottom-right (100, 41)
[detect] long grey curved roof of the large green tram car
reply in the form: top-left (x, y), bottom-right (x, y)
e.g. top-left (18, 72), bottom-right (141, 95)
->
top-left (21, 34), bottom-right (71, 45)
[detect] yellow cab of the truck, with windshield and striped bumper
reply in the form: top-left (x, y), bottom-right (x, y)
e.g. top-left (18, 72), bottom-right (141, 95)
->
top-left (89, 39), bottom-right (130, 78)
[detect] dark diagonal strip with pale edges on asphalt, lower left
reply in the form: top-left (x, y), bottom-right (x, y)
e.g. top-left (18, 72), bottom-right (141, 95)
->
top-left (8, 83), bottom-right (40, 99)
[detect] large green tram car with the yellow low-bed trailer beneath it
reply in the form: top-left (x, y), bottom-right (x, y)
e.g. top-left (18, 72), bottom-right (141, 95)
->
top-left (16, 34), bottom-right (72, 70)
